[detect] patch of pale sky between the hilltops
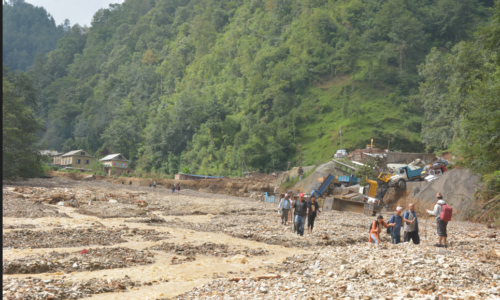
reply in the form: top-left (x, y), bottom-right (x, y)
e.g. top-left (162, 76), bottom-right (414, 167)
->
top-left (25, 0), bottom-right (123, 27)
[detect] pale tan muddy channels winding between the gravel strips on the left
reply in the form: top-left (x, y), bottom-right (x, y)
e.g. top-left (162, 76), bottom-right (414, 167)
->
top-left (3, 178), bottom-right (306, 299)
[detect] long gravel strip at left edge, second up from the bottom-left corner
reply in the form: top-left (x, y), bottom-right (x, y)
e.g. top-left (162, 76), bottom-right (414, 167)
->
top-left (3, 247), bottom-right (154, 274)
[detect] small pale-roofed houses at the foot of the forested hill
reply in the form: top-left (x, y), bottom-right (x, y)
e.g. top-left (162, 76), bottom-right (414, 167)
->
top-left (42, 149), bottom-right (131, 175)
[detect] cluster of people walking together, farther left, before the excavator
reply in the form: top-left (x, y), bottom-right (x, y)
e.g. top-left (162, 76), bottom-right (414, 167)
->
top-left (278, 191), bottom-right (319, 236)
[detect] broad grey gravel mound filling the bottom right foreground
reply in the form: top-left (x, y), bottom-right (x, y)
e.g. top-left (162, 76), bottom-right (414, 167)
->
top-left (171, 244), bottom-right (500, 300)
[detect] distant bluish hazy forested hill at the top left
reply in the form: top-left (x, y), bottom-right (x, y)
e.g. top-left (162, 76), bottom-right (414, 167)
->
top-left (2, 0), bottom-right (69, 71)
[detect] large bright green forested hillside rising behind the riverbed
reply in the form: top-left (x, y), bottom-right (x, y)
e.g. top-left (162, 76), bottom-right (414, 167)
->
top-left (23, 0), bottom-right (493, 175)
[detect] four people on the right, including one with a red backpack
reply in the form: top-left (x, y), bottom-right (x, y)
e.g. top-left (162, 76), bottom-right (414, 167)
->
top-left (368, 193), bottom-right (452, 248)
